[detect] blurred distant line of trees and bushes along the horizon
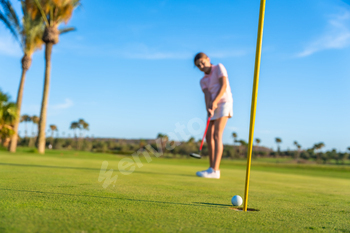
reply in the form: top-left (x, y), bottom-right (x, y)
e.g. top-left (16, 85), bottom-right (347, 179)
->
top-left (13, 131), bottom-right (350, 164)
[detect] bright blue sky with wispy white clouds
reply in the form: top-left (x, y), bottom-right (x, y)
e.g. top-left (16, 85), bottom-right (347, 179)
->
top-left (0, 0), bottom-right (350, 151)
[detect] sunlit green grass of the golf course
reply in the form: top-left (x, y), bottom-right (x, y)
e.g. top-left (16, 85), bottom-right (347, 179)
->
top-left (0, 150), bottom-right (350, 232)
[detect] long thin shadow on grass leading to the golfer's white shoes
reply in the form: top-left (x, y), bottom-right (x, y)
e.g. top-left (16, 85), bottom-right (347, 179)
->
top-left (0, 163), bottom-right (194, 177)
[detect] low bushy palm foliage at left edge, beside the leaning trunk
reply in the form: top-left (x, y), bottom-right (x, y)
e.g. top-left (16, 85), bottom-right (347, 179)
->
top-left (0, 90), bottom-right (19, 147)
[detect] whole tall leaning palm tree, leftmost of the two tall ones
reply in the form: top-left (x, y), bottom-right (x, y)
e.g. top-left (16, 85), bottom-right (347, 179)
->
top-left (0, 0), bottom-right (44, 152)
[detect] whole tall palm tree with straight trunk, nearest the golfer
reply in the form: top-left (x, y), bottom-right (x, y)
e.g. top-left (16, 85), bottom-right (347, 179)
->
top-left (26, 0), bottom-right (80, 153)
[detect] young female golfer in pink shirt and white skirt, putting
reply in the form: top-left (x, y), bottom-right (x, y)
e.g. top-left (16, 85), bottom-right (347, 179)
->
top-left (194, 53), bottom-right (233, 179)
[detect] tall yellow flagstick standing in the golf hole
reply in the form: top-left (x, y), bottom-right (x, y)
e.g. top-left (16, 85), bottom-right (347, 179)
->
top-left (243, 0), bottom-right (266, 211)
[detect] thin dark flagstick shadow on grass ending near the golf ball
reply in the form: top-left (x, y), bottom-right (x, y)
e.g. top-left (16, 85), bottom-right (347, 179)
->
top-left (0, 188), bottom-right (228, 208)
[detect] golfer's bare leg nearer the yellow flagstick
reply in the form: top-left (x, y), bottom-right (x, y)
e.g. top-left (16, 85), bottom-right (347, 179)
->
top-left (214, 117), bottom-right (228, 171)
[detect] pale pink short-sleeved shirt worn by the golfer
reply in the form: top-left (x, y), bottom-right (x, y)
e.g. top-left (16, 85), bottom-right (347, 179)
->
top-left (200, 63), bottom-right (233, 103)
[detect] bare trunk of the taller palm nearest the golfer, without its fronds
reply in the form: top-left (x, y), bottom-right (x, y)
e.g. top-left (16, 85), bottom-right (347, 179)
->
top-left (38, 42), bottom-right (53, 154)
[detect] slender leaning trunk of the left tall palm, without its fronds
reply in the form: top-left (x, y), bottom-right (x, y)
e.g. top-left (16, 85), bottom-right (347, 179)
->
top-left (9, 55), bottom-right (32, 153)
